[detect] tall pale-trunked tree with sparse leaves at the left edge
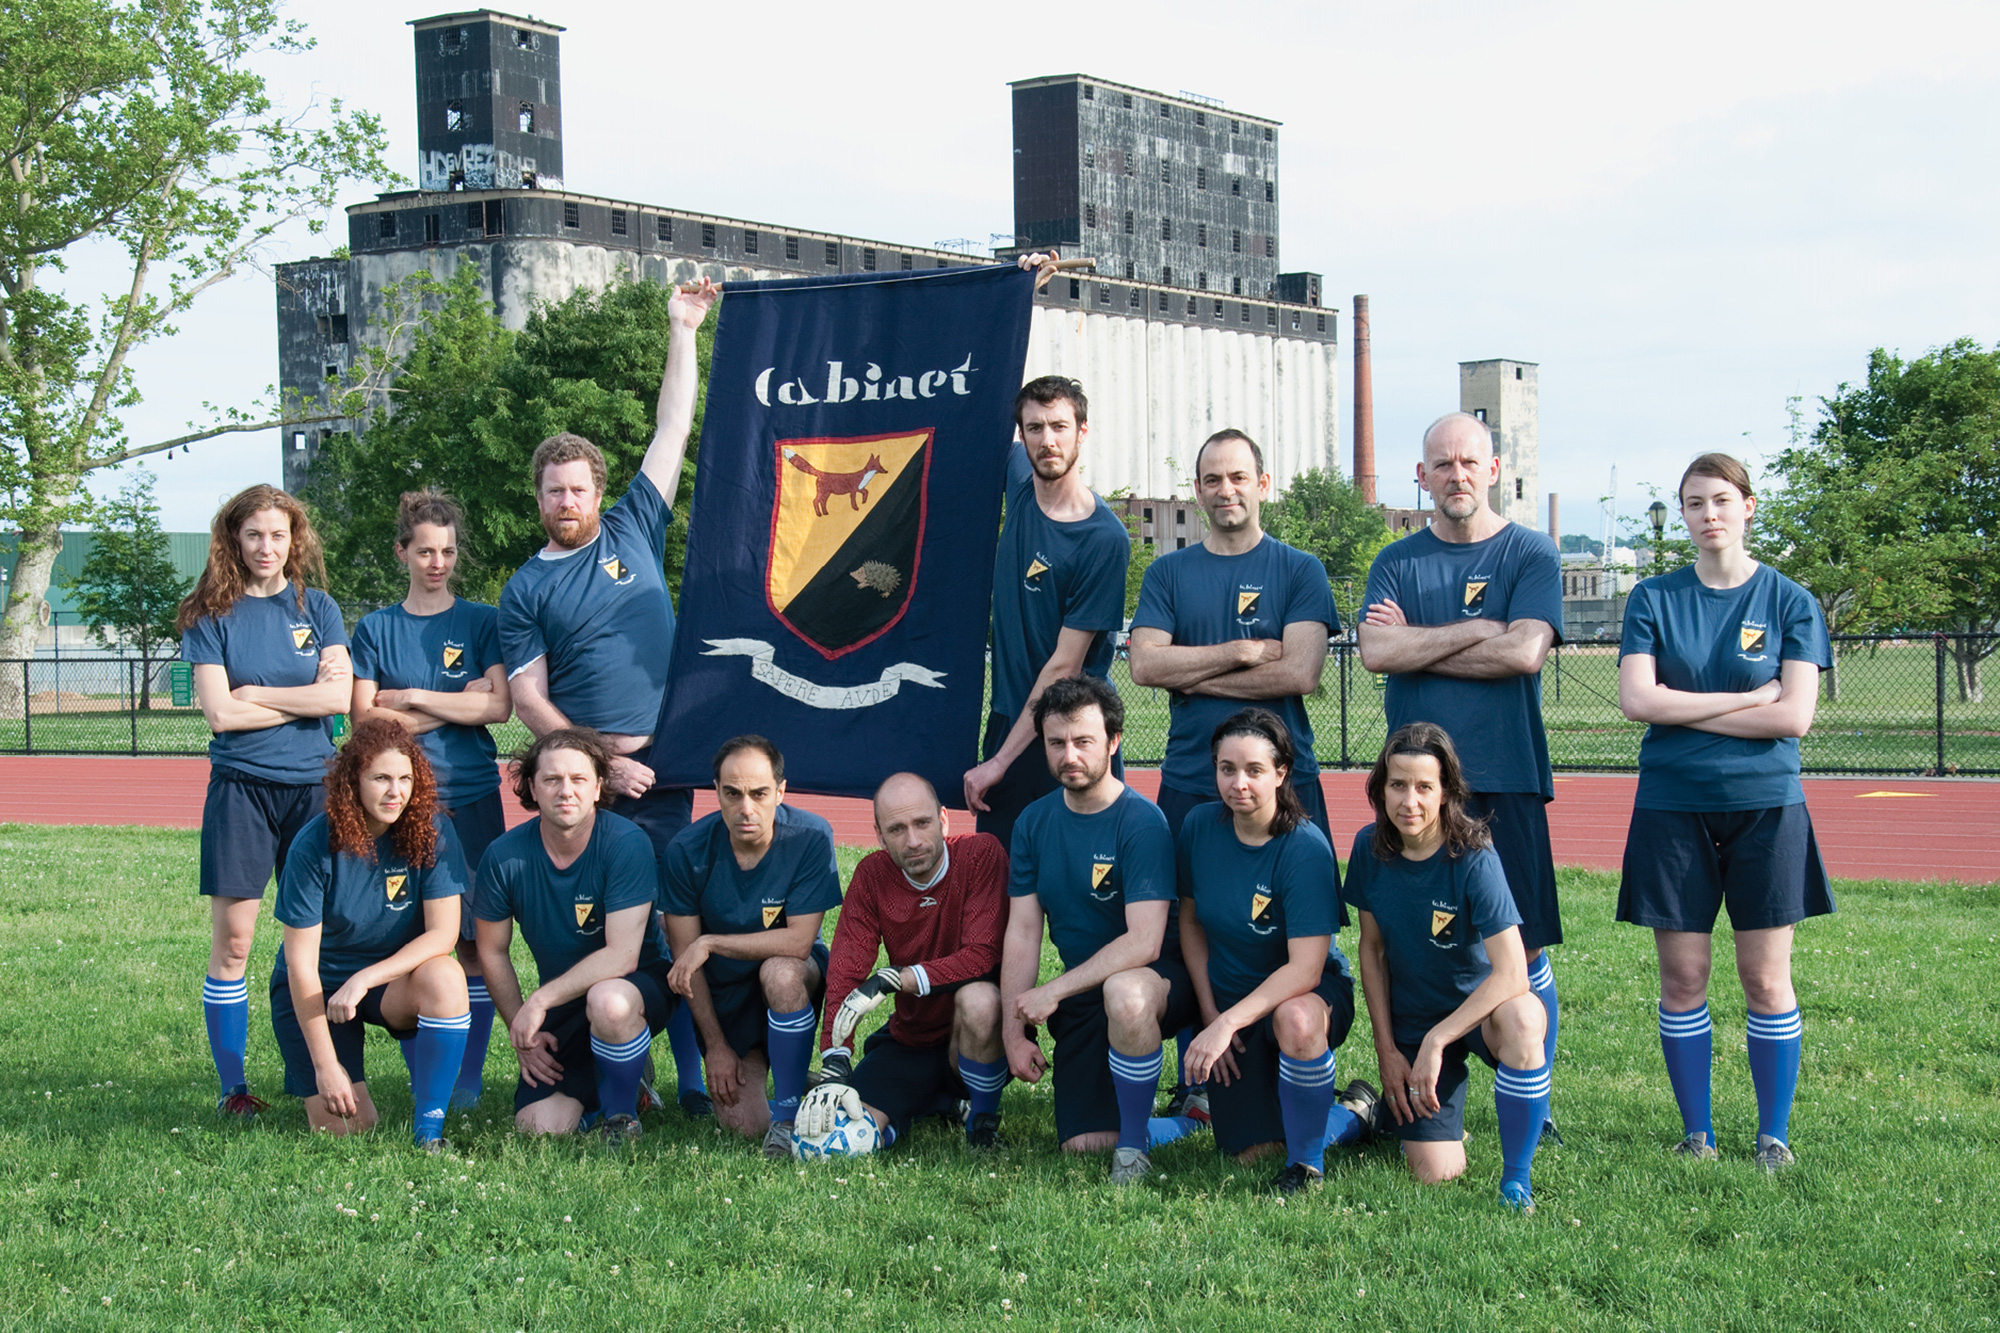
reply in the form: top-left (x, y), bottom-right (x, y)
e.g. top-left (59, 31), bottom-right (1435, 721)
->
top-left (0, 0), bottom-right (396, 713)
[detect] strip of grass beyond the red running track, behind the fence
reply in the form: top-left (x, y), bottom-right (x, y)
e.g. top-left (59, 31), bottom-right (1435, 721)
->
top-left (0, 642), bottom-right (2000, 775)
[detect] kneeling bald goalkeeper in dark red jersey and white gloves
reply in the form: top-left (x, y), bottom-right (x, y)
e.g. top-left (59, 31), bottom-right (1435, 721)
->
top-left (798, 773), bottom-right (1008, 1149)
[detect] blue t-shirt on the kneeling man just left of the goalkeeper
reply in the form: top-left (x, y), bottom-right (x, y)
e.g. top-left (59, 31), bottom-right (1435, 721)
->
top-left (660, 805), bottom-right (840, 987)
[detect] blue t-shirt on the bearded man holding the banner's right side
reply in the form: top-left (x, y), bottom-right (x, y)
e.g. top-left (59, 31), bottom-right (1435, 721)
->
top-left (992, 442), bottom-right (1132, 717)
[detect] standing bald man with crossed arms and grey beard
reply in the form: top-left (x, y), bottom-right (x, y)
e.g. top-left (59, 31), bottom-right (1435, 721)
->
top-left (1360, 412), bottom-right (1562, 1112)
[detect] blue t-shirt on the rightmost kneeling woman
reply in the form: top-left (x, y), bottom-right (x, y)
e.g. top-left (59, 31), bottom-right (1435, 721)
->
top-left (1344, 825), bottom-right (1520, 1047)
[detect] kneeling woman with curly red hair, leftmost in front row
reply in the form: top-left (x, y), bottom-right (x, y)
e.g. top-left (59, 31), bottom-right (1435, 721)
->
top-left (270, 719), bottom-right (472, 1147)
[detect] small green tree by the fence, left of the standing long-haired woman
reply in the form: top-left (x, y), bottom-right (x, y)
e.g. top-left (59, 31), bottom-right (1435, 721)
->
top-left (70, 472), bottom-right (194, 709)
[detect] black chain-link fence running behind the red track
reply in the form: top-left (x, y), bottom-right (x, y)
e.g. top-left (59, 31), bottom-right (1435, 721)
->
top-left (0, 634), bottom-right (2000, 775)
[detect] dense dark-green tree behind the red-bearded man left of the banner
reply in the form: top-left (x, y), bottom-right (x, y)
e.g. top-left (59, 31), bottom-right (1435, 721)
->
top-left (302, 264), bottom-right (718, 612)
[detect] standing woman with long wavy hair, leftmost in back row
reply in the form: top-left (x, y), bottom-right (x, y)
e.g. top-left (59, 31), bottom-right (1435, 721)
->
top-left (178, 486), bottom-right (350, 1117)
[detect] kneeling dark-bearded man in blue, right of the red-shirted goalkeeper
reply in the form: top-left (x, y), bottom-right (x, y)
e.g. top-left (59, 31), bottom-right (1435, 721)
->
top-left (1000, 677), bottom-right (1198, 1185)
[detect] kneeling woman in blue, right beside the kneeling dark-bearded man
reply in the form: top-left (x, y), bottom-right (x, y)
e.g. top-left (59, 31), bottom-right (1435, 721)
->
top-left (1180, 709), bottom-right (1376, 1195)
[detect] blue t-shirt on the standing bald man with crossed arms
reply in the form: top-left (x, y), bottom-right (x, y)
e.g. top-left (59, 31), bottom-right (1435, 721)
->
top-left (1368, 522), bottom-right (1562, 801)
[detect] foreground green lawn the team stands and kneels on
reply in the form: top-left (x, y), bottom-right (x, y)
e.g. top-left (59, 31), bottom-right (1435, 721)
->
top-left (0, 825), bottom-right (2000, 1333)
